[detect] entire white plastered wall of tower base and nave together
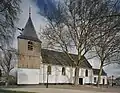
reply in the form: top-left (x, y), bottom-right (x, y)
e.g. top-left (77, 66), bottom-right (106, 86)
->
top-left (17, 64), bottom-right (92, 84)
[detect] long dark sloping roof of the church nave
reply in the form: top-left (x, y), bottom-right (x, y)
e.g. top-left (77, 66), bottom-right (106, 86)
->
top-left (41, 49), bottom-right (92, 68)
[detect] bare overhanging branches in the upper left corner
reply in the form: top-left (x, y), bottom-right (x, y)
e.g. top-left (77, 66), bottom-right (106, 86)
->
top-left (0, 0), bottom-right (21, 46)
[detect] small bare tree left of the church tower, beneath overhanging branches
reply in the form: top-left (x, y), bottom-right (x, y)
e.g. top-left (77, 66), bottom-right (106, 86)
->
top-left (0, 48), bottom-right (17, 85)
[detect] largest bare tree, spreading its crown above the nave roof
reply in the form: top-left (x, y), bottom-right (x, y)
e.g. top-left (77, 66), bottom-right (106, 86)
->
top-left (40, 0), bottom-right (118, 85)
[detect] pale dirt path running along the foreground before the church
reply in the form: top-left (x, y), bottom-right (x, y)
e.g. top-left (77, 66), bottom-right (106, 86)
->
top-left (4, 85), bottom-right (120, 93)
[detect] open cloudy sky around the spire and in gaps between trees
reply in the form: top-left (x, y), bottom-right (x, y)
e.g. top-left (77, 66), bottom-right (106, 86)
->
top-left (14, 0), bottom-right (120, 77)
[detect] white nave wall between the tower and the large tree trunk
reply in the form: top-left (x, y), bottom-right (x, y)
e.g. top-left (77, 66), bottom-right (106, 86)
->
top-left (40, 64), bottom-right (73, 83)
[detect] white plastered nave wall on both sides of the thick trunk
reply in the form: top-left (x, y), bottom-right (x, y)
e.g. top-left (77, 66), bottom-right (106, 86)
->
top-left (39, 64), bottom-right (93, 84)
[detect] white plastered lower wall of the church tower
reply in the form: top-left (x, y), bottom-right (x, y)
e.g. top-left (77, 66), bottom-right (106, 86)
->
top-left (17, 68), bottom-right (40, 84)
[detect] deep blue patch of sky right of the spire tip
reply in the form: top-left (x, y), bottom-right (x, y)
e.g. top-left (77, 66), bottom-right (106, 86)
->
top-left (36, 0), bottom-right (64, 21)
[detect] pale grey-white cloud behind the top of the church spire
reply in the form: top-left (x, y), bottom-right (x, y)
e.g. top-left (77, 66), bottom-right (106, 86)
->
top-left (18, 0), bottom-right (45, 32)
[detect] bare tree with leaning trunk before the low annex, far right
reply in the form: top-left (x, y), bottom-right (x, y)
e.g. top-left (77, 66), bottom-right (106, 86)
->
top-left (86, 0), bottom-right (120, 86)
